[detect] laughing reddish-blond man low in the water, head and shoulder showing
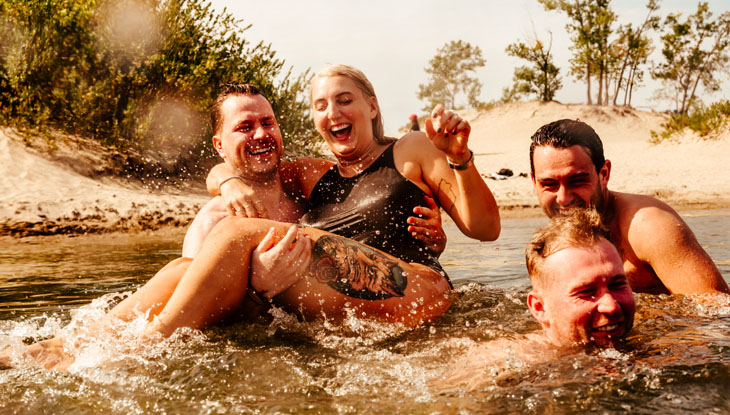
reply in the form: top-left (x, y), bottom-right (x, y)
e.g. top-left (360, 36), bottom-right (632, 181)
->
top-left (435, 209), bottom-right (635, 388)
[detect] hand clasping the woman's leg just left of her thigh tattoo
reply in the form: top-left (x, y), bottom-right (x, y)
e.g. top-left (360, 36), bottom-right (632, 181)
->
top-left (250, 225), bottom-right (312, 300)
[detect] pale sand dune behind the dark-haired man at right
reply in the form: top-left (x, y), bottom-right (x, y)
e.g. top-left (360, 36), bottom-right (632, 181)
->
top-left (462, 102), bottom-right (730, 211)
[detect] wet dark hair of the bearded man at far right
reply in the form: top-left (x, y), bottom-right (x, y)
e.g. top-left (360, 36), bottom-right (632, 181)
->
top-left (530, 119), bottom-right (606, 176)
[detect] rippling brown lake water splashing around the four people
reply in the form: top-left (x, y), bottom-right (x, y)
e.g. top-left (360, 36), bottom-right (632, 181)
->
top-left (0, 210), bottom-right (730, 415)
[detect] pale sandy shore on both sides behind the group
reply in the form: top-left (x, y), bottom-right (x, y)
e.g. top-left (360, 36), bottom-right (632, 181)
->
top-left (0, 102), bottom-right (730, 236)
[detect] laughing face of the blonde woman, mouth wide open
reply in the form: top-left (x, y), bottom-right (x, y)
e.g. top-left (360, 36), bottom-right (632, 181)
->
top-left (311, 76), bottom-right (378, 159)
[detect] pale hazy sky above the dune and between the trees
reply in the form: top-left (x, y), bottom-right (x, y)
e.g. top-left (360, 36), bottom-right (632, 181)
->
top-left (212, 0), bottom-right (730, 135)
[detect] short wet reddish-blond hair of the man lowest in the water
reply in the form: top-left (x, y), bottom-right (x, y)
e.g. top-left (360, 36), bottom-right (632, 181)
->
top-left (525, 209), bottom-right (610, 287)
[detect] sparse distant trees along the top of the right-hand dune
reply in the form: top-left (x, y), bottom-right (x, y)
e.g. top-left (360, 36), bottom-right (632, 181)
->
top-left (417, 0), bottom-right (730, 120)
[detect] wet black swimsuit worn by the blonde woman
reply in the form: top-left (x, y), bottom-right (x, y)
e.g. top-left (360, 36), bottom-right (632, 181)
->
top-left (300, 144), bottom-right (448, 280)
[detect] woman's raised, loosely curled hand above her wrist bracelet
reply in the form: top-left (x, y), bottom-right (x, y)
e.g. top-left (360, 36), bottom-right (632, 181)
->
top-left (425, 104), bottom-right (471, 164)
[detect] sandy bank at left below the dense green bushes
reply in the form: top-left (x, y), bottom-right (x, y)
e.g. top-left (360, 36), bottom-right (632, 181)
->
top-left (0, 130), bottom-right (208, 236)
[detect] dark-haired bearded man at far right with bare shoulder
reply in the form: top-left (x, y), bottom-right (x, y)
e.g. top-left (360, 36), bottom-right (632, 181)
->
top-left (530, 120), bottom-right (730, 294)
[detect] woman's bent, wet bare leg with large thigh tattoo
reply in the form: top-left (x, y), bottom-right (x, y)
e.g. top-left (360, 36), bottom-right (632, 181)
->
top-left (144, 217), bottom-right (450, 336)
